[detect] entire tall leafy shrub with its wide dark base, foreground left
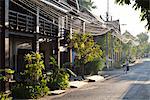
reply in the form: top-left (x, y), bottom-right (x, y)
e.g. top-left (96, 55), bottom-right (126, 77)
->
top-left (13, 52), bottom-right (49, 99)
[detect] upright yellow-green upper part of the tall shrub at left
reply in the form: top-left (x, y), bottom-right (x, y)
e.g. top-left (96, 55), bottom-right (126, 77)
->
top-left (25, 52), bottom-right (45, 83)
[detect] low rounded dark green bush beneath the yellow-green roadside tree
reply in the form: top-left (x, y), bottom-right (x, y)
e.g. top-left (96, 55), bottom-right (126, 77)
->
top-left (85, 59), bottom-right (105, 75)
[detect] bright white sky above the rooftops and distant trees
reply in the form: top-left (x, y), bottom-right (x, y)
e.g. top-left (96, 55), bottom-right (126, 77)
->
top-left (92, 0), bottom-right (146, 36)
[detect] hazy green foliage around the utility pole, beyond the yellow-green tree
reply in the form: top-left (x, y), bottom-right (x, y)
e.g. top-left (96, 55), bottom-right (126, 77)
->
top-left (97, 32), bottom-right (122, 68)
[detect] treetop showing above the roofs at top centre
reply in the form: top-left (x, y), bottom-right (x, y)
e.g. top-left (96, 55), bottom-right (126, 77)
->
top-left (79, 0), bottom-right (96, 10)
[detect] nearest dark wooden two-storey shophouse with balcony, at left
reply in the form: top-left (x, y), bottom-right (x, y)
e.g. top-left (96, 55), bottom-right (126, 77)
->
top-left (0, 0), bottom-right (81, 85)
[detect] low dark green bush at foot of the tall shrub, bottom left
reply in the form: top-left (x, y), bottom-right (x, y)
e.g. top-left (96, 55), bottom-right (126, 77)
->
top-left (12, 80), bottom-right (49, 99)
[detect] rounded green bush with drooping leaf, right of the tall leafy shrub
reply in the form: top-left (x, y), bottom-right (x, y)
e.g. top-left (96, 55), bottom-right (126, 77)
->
top-left (47, 57), bottom-right (71, 90)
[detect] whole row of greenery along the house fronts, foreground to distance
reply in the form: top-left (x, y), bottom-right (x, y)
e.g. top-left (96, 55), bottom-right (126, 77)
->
top-left (0, 32), bottom-right (150, 100)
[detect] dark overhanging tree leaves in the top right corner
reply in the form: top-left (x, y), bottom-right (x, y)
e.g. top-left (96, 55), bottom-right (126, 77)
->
top-left (116, 0), bottom-right (150, 30)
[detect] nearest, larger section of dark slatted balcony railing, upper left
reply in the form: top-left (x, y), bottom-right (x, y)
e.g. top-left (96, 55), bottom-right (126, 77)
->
top-left (9, 10), bottom-right (36, 32)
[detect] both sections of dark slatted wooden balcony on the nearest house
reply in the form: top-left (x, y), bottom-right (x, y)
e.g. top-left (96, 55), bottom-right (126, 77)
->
top-left (9, 10), bottom-right (58, 37)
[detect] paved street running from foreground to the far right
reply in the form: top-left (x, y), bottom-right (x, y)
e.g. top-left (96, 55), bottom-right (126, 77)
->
top-left (49, 59), bottom-right (150, 100)
